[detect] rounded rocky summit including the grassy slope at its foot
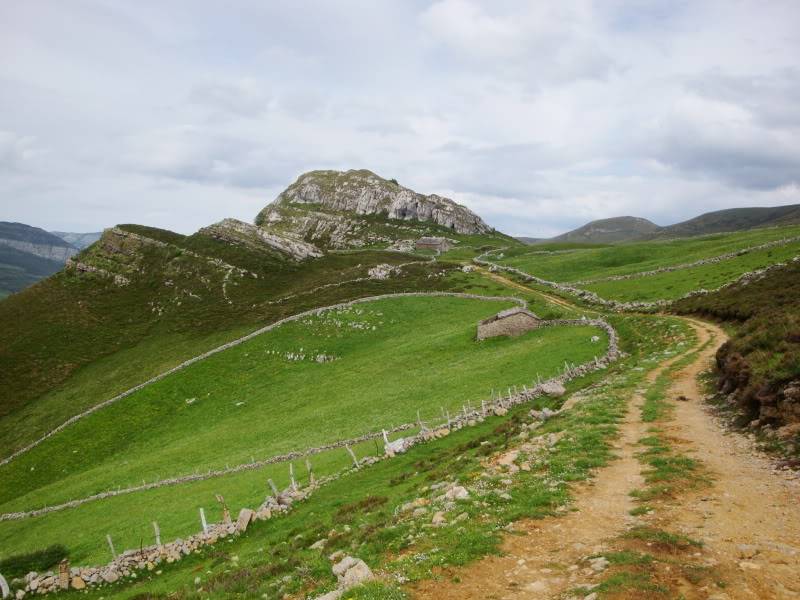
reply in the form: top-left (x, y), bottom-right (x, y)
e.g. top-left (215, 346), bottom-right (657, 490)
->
top-left (256, 170), bottom-right (492, 248)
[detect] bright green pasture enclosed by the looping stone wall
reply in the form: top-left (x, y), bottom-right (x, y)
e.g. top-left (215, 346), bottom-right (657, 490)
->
top-left (0, 298), bottom-right (604, 558)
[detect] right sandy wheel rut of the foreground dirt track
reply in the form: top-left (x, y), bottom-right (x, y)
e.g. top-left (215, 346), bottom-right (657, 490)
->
top-left (653, 321), bottom-right (800, 599)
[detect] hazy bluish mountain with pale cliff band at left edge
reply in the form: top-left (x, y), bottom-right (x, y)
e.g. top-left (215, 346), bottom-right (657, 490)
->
top-left (0, 221), bottom-right (78, 297)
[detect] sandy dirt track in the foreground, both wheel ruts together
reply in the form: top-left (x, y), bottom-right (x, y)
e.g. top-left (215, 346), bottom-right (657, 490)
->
top-left (414, 310), bottom-right (800, 600)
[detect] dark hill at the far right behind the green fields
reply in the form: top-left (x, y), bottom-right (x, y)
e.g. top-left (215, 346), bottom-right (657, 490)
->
top-left (656, 204), bottom-right (800, 237)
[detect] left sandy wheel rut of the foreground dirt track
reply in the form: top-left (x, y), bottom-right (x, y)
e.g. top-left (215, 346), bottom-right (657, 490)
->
top-left (413, 357), bottom-right (679, 600)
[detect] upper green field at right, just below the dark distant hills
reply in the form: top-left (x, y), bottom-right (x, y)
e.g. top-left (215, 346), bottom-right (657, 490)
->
top-left (496, 226), bottom-right (800, 283)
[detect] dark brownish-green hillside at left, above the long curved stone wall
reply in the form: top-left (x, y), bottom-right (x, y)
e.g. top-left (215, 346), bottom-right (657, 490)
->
top-left (0, 226), bottom-right (482, 455)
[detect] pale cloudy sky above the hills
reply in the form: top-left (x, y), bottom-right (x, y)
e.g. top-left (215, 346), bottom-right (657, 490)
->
top-left (0, 0), bottom-right (800, 237)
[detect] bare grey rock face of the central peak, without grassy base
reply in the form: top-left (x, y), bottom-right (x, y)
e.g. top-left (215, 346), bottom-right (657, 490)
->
top-left (256, 170), bottom-right (492, 245)
